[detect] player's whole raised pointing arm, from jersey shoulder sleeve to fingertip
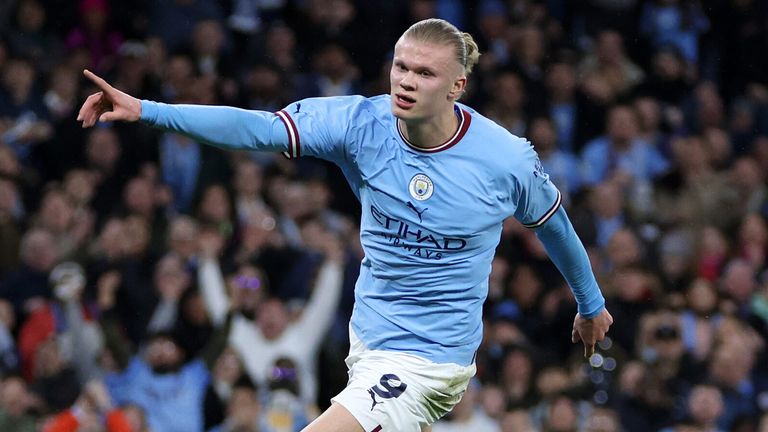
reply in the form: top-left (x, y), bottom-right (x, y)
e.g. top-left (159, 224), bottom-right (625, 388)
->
top-left (77, 70), bottom-right (356, 164)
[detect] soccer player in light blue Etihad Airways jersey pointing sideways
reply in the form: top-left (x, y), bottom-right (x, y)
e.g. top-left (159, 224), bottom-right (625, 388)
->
top-left (78, 19), bottom-right (613, 432)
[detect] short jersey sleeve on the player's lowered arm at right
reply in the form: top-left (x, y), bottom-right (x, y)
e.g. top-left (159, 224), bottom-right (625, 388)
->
top-left (512, 145), bottom-right (562, 228)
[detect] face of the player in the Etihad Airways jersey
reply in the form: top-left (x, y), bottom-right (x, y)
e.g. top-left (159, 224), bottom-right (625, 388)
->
top-left (389, 38), bottom-right (467, 121)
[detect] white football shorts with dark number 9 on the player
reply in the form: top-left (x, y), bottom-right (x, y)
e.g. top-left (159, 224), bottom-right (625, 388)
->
top-left (331, 328), bottom-right (476, 432)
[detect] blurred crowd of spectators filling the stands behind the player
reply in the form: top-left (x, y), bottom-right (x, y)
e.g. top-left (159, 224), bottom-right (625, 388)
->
top-left (0, 0), bottom-right (768, 432)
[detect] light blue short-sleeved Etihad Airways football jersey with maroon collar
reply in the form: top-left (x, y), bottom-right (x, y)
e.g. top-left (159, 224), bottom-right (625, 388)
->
top-left (277, 95), bottom-right (561, 365)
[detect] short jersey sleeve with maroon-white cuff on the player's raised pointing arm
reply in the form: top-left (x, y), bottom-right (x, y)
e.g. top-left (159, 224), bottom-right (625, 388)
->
top-left (275, 96), bottom-right (362, 162)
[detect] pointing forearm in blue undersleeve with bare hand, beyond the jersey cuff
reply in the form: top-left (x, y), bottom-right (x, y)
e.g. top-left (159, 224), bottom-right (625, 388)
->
top-left (77, 70), bottom-right (289, 152)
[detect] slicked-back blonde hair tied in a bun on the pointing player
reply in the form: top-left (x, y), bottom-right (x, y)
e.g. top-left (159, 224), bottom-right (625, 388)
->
top-left (401, 18), bottom-right (480, 76)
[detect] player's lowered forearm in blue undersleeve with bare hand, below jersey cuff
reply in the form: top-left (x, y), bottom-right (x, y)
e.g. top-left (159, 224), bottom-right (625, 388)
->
top-left (536, 207), bottom-right (613, 357)
